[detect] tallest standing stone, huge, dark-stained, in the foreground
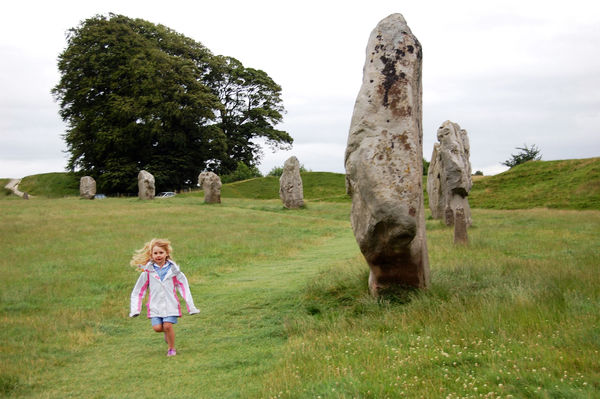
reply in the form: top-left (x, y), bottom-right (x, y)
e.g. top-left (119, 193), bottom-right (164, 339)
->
top-left (345, 14), bottom-right (429, 295)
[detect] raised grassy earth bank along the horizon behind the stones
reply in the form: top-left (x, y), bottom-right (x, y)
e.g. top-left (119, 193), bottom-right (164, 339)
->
top-left (5, 158), bottom-right (600, 210)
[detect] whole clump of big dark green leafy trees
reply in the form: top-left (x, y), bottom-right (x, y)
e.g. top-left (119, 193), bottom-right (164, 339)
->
top-left (52, 14), bottom-right (293, 192)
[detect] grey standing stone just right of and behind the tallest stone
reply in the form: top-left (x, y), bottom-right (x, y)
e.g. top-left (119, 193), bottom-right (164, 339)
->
top-left (427, 121), bottom-right (473, 226)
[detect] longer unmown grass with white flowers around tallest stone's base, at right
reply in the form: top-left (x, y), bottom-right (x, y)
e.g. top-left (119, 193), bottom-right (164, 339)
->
top-left (268, 210), bottom-right (600, 398)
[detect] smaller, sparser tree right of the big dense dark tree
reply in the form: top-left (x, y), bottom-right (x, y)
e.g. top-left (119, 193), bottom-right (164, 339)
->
top-left (206, 56), bottom-right (293, 173)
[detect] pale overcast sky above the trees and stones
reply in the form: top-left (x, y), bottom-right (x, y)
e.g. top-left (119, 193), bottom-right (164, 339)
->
top-left (0, 0), bottom-right (600, 178)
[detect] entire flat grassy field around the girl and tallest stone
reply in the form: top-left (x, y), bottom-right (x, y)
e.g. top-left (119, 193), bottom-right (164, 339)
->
top-left (0, 193), bottom-right (600, 398)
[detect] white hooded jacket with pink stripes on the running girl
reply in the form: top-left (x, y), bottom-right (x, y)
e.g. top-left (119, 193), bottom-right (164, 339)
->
top-left (129, 260), bottom-right (200, 318)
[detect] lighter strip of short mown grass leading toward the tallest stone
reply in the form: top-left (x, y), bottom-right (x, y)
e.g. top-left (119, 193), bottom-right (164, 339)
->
top-left (44, 232), bottom-right (357, 398)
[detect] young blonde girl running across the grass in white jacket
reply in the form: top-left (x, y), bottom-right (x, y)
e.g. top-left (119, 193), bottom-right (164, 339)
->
top-left (129, 238), bottom-right (200, 356)
